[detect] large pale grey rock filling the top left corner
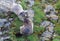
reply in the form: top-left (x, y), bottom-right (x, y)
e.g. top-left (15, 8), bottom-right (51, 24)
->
top-left (0, 0), bottom-right (15, 11)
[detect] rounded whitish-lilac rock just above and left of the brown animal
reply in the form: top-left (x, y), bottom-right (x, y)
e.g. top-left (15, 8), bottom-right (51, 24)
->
top-left (11, 3), bottom-right (24, 16)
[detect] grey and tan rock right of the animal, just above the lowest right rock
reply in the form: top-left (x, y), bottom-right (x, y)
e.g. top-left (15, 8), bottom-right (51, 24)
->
top-left (40, 21), bottom-right (55, 33)
